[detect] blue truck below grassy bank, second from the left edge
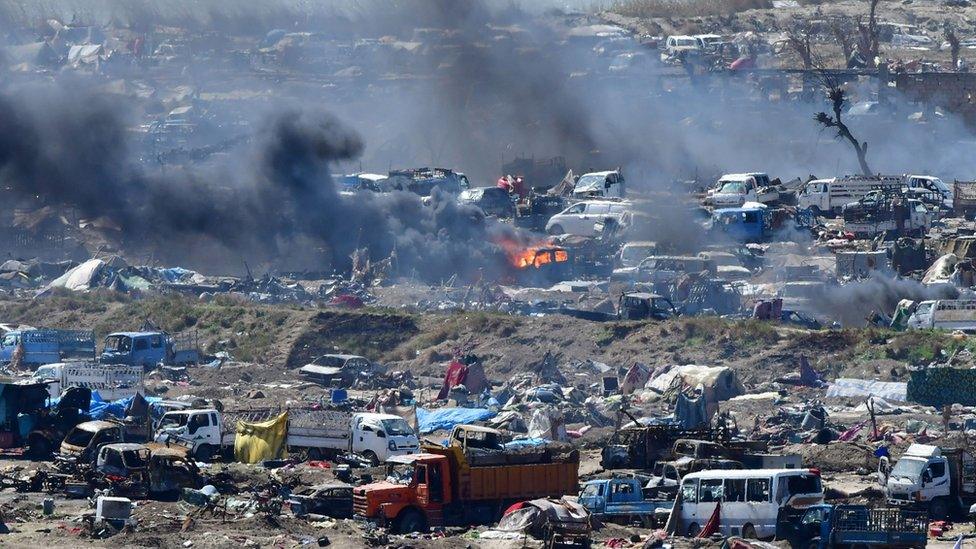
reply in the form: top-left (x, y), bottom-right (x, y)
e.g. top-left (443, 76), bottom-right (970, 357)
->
top-left (99, 331), bottom-right (200, 370)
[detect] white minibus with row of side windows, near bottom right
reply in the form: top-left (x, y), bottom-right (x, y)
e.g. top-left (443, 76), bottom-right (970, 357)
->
top-left (672, 469), bottom-right (824, 539)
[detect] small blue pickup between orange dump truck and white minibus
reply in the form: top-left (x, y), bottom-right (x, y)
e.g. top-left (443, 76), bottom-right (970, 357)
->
top-left (579, 478), bottom-right (674, 528)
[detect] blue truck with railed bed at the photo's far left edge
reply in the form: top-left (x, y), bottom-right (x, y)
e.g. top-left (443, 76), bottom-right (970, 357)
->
top-left (0, 328), bottom-right (95, 367)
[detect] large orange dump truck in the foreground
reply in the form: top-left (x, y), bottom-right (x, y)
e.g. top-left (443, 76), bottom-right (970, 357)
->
top-left (353, 426), bottom-right (579, 533)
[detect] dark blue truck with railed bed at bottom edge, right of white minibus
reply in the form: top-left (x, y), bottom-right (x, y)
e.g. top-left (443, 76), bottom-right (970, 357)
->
top-left (776, 504), bottom-right (929, 549)
